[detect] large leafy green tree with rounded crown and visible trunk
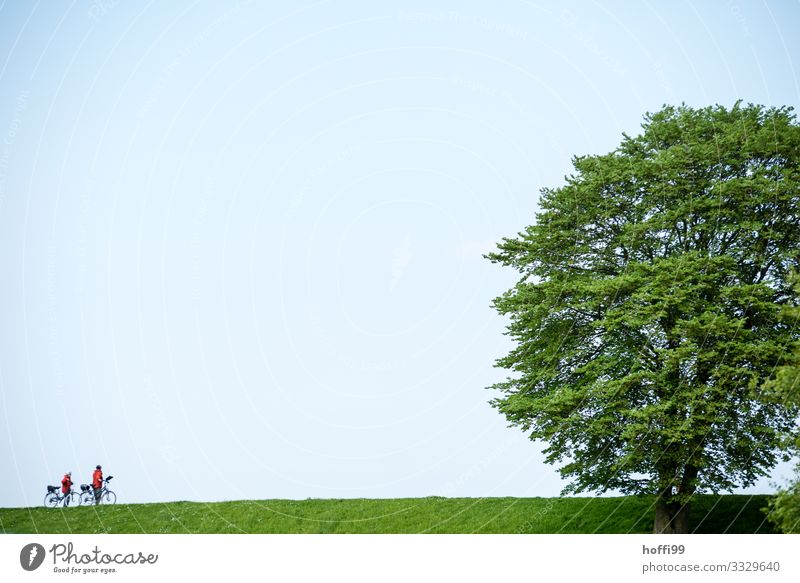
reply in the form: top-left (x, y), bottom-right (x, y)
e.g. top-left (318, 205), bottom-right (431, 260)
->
top-left (487, 103), bottom-right (800, 533)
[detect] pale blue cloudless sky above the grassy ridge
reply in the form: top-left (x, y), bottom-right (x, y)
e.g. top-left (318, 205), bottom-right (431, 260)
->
top-left (0, 0), bottom-right (800, 506)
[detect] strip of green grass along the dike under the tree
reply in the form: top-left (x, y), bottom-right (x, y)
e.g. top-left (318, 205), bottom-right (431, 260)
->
top-left (0, 495), bottom-right (774, 534)
